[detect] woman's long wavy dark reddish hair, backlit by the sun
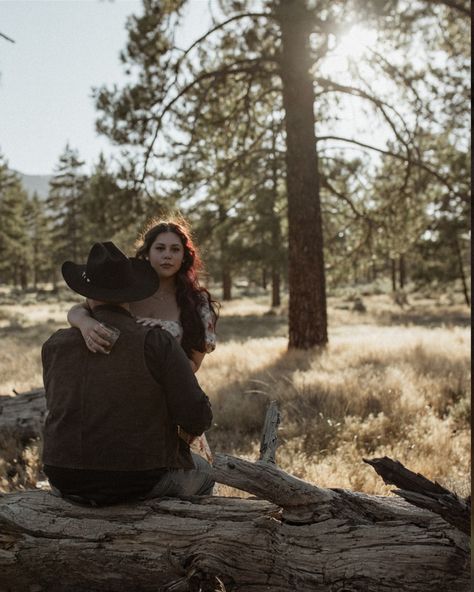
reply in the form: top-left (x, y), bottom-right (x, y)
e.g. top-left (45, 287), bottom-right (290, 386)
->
top-left (136, 220), bottom-right (219, 357)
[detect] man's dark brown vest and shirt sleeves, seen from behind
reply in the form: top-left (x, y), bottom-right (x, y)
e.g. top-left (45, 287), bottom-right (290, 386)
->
top-left (42, 305), bottom-right (212, 471)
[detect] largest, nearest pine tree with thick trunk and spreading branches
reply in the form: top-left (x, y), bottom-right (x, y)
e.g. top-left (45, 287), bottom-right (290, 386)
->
top-left (91, 0), bottom-right (465, 348)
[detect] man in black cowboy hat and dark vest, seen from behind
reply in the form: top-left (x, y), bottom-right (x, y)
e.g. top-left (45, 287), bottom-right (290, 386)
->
top-left (42, 242), bottom-right (213, 505)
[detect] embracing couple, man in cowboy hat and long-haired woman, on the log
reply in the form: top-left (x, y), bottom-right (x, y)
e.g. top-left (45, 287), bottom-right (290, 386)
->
top-left (42, 222), bottom-right (217, 505)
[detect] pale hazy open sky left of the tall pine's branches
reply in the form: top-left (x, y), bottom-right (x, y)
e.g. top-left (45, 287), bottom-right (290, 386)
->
top-left (0, 0), bottom-right (207, 174)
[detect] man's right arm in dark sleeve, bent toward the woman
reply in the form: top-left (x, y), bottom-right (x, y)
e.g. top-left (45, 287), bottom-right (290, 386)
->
top-left (145, 328), bottom-right (212, 436)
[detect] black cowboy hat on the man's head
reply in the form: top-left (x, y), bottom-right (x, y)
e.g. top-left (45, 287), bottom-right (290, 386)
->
top-left (61, 242), bottom-right (160, 303)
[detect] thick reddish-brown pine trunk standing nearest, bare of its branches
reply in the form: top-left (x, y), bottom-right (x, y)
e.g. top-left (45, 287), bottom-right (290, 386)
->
top-left (276, 0), bottom-right (328, 349)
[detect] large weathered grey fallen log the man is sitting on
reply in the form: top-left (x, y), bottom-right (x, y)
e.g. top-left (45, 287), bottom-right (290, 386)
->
top-left (0, 400), bottom-right (470, 592)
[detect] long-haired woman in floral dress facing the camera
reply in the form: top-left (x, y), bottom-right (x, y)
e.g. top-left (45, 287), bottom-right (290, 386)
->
top-left (67, 221), bottom-right (218, 457)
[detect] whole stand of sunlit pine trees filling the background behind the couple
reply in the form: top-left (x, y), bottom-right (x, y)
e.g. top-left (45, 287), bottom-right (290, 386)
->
top-left (0, 0), bottom-right (470, 314)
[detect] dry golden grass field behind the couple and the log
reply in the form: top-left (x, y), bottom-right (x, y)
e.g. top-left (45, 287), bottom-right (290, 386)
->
top-left (0, 286), bottom-right (470, 495)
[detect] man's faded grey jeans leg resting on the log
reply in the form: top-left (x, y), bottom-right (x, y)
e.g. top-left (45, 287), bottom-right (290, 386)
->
top-left (143, 452), bottom-right (214, 499)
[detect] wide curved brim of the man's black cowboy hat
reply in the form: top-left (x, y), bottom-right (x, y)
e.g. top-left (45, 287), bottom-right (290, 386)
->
top-left (61, 257), bottom-right (160, 303)
